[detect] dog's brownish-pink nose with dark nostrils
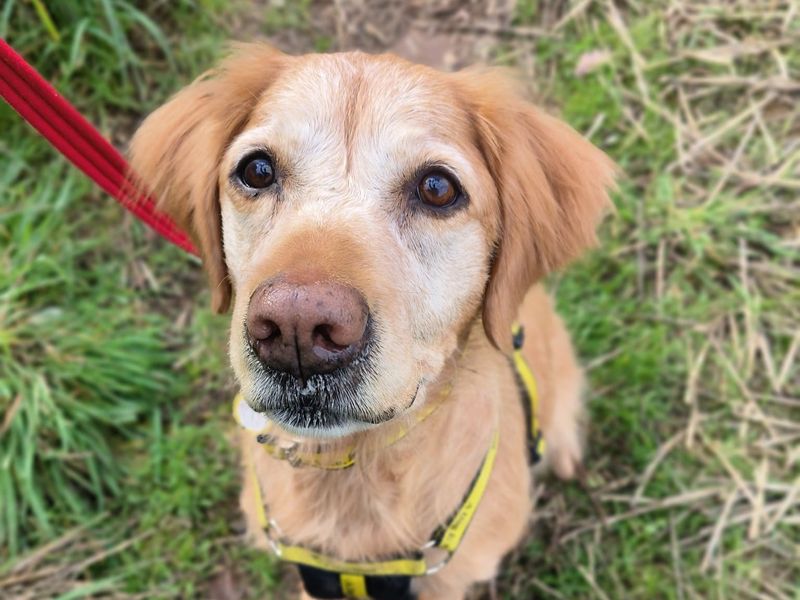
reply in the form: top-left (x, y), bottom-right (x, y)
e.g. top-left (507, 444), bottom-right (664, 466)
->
top-left (247, 280), bottom-right (369, 379)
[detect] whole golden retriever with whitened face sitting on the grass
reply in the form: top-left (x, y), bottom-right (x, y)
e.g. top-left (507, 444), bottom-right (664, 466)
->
top-left (131, 44), bottom-right (614, 599)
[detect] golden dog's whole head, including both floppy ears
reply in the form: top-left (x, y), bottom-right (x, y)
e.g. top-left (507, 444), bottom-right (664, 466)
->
top-left (131, 45), bottom-right (613, 436)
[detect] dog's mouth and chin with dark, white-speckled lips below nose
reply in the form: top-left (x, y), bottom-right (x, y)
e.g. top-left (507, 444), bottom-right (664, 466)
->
top-left (245, 344), bottom-right (395, 437)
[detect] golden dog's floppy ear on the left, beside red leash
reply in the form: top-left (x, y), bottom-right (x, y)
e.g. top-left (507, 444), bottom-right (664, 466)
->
top-left (130, 44), bottom-right (289, 312)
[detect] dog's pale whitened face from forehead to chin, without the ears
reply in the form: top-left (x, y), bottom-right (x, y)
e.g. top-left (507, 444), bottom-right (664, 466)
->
top-left (219, 55), bottom-right (497, 435)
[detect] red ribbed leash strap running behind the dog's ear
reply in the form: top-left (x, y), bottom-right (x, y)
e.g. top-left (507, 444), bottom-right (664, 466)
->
top-left (0, 38), bottom-right (197, 254)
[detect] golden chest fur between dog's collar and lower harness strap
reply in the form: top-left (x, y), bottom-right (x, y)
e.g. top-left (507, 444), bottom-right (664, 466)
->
top-left (250, 412), bottom-right (490, 560)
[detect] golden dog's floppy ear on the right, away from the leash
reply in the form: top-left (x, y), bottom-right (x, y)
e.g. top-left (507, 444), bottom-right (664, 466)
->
top-left (458, 71), bottom-right (616, 351)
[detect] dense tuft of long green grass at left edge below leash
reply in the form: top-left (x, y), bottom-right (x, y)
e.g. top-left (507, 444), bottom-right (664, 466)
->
top-left (0, 162), bottom-right (186, 552)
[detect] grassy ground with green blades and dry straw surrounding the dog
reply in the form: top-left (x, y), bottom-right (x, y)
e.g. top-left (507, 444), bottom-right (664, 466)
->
top-left (0, 0), bottom-right (800, 600)
